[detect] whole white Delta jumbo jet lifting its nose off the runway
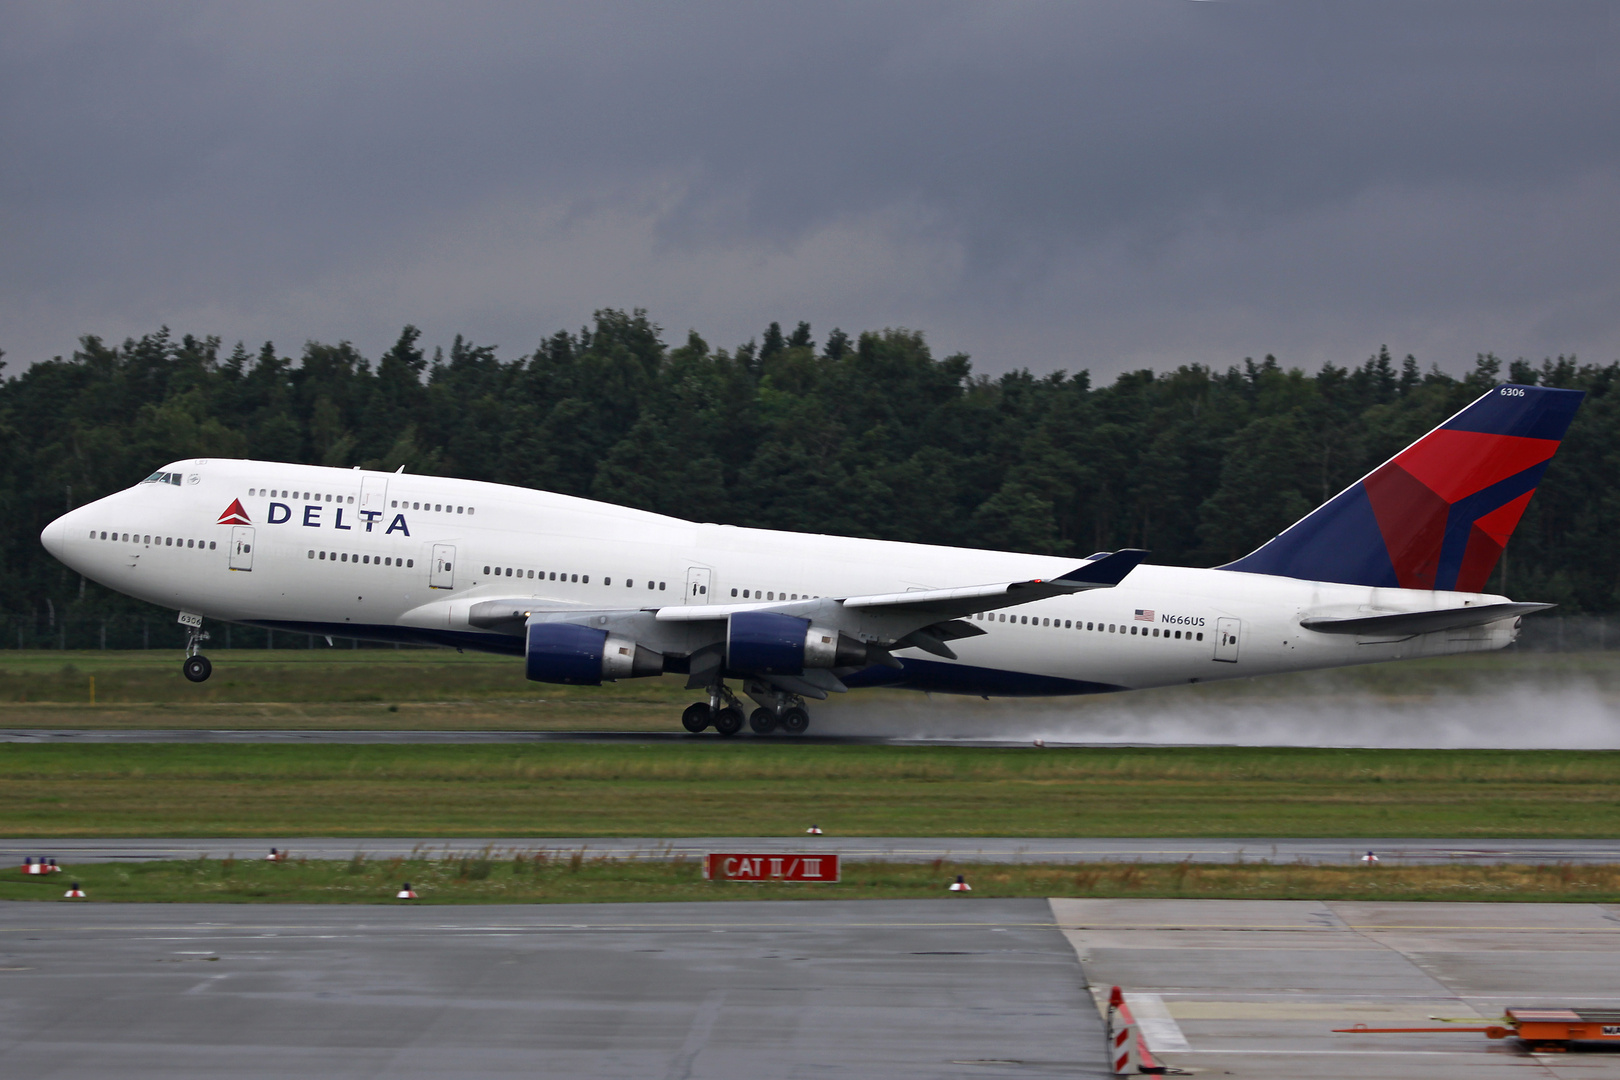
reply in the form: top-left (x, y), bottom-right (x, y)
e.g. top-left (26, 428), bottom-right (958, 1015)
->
top-left (41, 385), bottom-right (1581, 735)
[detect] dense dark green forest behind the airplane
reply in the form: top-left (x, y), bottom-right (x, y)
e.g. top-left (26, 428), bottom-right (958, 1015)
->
top-left (0, 309), bottom-right (1620, 646)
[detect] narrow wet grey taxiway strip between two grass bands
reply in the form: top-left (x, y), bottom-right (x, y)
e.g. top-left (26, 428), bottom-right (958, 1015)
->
top-left (9, 836), bottom-right (1620, 866)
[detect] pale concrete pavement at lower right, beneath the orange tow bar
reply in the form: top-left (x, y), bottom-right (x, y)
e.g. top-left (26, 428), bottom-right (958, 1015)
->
top-left (1051, 900), bottom-right (1620, 1080)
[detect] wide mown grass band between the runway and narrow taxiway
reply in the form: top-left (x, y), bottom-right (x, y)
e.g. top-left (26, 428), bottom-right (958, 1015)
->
top-left (0, 738), bottom-right (1620, 840)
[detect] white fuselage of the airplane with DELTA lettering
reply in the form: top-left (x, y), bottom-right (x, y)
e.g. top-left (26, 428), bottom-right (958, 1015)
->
top-left (44, 460), bottom-right (1516, 695)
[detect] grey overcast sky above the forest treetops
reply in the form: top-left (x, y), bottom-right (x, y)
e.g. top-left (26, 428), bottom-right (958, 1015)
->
top-left (0, 0), bottom-right (1620, 376)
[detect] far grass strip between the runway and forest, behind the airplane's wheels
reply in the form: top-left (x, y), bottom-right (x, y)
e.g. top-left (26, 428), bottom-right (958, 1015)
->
top-left (0, 649), bottom-right (1620, 732)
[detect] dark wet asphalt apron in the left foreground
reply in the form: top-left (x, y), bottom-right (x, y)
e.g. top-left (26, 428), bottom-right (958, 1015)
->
top-left (0, 900), bottom-right (1106, 1080)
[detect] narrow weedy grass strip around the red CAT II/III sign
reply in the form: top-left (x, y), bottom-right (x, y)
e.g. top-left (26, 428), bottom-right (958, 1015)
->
top-left (12, 850), bottom-right (1620, 904)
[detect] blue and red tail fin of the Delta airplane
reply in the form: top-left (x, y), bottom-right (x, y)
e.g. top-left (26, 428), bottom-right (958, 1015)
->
top-left (1223, 384), bottom-right (1584, 593)
